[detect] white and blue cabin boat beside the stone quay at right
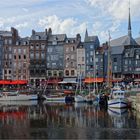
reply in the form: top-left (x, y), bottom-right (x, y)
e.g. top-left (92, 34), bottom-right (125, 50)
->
top-left (108, 90), bottom-right (128, 108)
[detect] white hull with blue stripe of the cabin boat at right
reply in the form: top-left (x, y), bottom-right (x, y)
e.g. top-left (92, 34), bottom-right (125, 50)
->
top-left (108, 98), bottom-right (128, 108)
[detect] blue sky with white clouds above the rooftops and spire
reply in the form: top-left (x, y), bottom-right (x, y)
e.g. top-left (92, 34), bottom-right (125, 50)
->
top-left (0, 0), bottom-right (140, 43)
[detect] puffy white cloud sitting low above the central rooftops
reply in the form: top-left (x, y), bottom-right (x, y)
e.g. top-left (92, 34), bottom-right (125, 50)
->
top-left (38, 15), bottom-right (87, 36)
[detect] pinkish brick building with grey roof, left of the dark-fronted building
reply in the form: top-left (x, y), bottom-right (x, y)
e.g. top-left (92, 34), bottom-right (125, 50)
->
top-left (12, 37), bottom-right (30, 81)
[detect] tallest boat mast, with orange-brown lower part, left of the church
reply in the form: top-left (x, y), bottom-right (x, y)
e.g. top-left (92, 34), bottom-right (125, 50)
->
top-left (107, 31), bottom-right (112, 89)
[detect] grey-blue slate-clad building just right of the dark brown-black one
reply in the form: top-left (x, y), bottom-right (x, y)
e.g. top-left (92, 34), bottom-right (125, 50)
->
top-left (46, 28), bottom-right (66, 79)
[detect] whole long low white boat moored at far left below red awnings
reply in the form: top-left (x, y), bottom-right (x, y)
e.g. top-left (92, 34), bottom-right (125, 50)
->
top-left (0, 92), bottom-right (38, 101)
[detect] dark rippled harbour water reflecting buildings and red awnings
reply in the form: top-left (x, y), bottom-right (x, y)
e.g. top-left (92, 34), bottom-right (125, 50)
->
top-left (0, 102), bottom-right (140, 139)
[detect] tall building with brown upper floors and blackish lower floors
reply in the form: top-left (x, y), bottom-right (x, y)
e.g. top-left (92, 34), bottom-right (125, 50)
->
top-left (29, 29), bottom-right (48, 86)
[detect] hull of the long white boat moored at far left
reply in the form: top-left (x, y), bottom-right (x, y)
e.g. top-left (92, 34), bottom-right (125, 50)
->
top-left (0, 94), bottom-right (38, 101)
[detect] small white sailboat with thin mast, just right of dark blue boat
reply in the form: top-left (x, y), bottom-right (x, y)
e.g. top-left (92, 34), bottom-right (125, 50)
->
top-left (74, 70), bottom-right (85, 102)
